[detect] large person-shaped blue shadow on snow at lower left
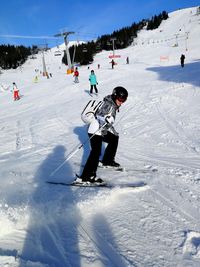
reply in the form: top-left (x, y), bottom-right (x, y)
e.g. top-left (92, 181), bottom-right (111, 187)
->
top-left (20, 146), bottom-right (81, 267)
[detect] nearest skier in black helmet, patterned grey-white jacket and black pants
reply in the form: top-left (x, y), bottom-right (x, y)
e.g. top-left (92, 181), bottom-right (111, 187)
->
top-left (77, 86), bottom-right (128, 183)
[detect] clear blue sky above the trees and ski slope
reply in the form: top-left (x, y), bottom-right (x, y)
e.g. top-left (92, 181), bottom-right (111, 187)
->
top-left (0, 0), bottom-right (200, 47)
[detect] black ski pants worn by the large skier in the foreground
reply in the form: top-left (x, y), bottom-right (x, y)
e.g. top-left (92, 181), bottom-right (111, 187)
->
top-left (81, 132), bottom-right (119, 180)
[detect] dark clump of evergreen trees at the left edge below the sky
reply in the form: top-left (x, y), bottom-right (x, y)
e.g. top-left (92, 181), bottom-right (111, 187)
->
top-left (0, 45), bottom-right (36, 69)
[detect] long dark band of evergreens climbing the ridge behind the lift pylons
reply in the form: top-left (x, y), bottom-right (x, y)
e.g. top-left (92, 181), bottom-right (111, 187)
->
top-left (62, 11), bottom-right (168, 65)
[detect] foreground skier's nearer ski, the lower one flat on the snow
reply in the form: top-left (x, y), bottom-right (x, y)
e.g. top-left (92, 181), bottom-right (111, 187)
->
top-left (46, 181), bottom-right (147, 188)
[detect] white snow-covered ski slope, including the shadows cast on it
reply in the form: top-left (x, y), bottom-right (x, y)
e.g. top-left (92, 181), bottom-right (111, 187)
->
top-left (0, 8), bottom-right (200, 267)
